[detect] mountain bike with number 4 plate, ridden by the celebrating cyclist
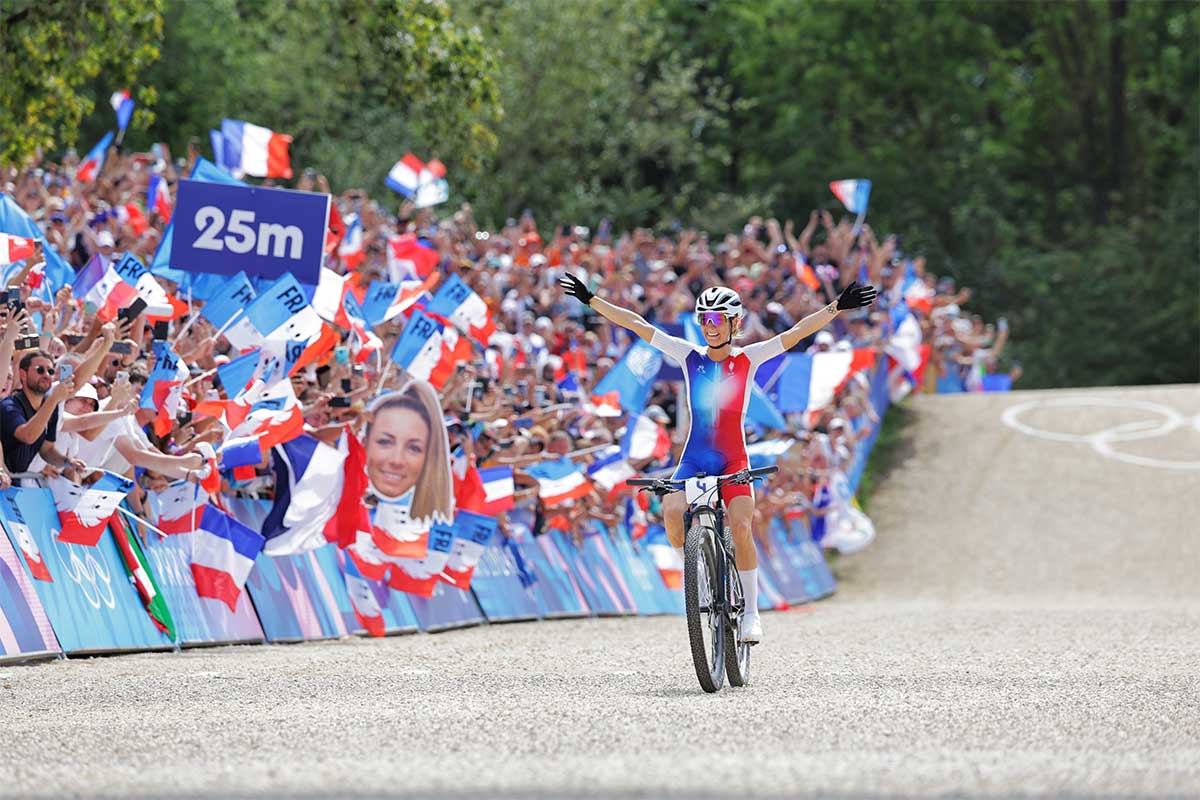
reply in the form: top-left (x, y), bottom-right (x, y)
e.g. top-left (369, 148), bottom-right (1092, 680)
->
top-left (629, 467), bottom-right (779, 692)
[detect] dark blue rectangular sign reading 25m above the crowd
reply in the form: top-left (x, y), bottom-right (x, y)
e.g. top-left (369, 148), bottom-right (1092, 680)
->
top-left (170, 181), bottom-right (329, 283)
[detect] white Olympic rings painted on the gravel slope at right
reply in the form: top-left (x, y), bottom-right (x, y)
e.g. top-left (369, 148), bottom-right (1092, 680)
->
top-left (1001, 396), bottom-right (1200, 469)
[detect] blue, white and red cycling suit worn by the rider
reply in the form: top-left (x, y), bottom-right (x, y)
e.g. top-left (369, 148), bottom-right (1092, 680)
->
top-left (650, 330), bottom-right (784, 499)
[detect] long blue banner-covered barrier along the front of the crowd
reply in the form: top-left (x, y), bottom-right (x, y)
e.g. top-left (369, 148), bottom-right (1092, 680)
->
top-left (0, 368), bottom-right (888, 661)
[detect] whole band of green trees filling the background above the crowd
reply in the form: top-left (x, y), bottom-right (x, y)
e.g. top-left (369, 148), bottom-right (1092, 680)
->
top-left (0, 0), bottom-right (1200, 386)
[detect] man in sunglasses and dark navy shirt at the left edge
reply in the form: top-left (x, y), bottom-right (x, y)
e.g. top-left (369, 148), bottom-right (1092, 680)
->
top-left (0, 350), bottom-right (86, 475)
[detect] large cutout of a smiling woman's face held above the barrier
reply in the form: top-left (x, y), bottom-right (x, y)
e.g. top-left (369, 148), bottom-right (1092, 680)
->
top-left (365, 380), bottom-right (454, 519)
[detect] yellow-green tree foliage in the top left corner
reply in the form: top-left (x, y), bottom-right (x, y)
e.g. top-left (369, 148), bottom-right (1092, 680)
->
top-left (0, 0), bottom-right (163, 164)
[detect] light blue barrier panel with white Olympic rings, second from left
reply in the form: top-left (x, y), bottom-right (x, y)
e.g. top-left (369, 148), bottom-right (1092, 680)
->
top-left (0, 488), bottom-right (174, 654)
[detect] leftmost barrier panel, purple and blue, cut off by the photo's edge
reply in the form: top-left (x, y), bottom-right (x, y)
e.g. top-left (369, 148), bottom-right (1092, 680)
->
top-left (0, 506), bottom-right (61, 662)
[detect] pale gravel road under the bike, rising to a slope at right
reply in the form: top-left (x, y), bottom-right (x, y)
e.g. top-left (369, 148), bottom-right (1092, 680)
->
top-left (0, 386), bottom-right (1200, 798)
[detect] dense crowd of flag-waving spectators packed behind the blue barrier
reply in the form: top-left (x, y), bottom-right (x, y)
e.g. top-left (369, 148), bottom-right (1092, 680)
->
top-left (0, 140), bottom-right (1019, 561)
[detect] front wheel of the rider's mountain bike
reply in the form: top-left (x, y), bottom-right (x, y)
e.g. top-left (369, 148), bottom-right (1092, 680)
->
top-left (683, 512), bottom-right (726, 692)
